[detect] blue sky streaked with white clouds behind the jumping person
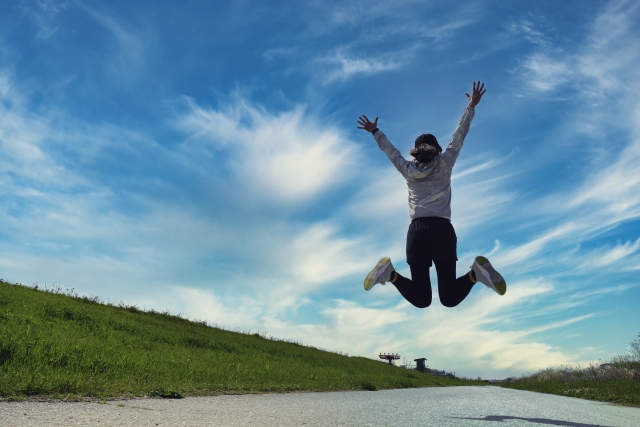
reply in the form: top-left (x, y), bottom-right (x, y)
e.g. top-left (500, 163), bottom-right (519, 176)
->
top-left (0, 0), bottom-right (640, 377)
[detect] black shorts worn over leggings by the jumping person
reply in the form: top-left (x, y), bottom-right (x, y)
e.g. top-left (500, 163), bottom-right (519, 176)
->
top-left (407, 217), bottom-right (458, 267)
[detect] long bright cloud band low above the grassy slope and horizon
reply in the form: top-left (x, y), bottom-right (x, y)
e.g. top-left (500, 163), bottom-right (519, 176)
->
top-left (148, 281), bottom-right (595, 376)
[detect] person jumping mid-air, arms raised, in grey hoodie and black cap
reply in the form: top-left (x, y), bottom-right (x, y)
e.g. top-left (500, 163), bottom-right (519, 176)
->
top-left (358, 81), bottom-right (507, 308)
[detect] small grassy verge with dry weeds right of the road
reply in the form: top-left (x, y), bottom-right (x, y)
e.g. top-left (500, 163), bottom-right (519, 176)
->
top-left (501, 357), bottom-right (640, 406)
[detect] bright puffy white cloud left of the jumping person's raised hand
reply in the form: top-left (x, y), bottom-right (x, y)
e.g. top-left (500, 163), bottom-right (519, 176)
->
top-left (172, 99), bottom-right (354, 203)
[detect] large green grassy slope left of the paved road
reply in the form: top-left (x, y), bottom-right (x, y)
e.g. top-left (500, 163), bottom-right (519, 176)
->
top-left (0, 281), bottom-right (482, 399)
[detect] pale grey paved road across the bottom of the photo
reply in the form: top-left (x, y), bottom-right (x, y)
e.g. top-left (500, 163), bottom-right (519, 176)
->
top-left (0, 387), bottom-right (640, 427)
